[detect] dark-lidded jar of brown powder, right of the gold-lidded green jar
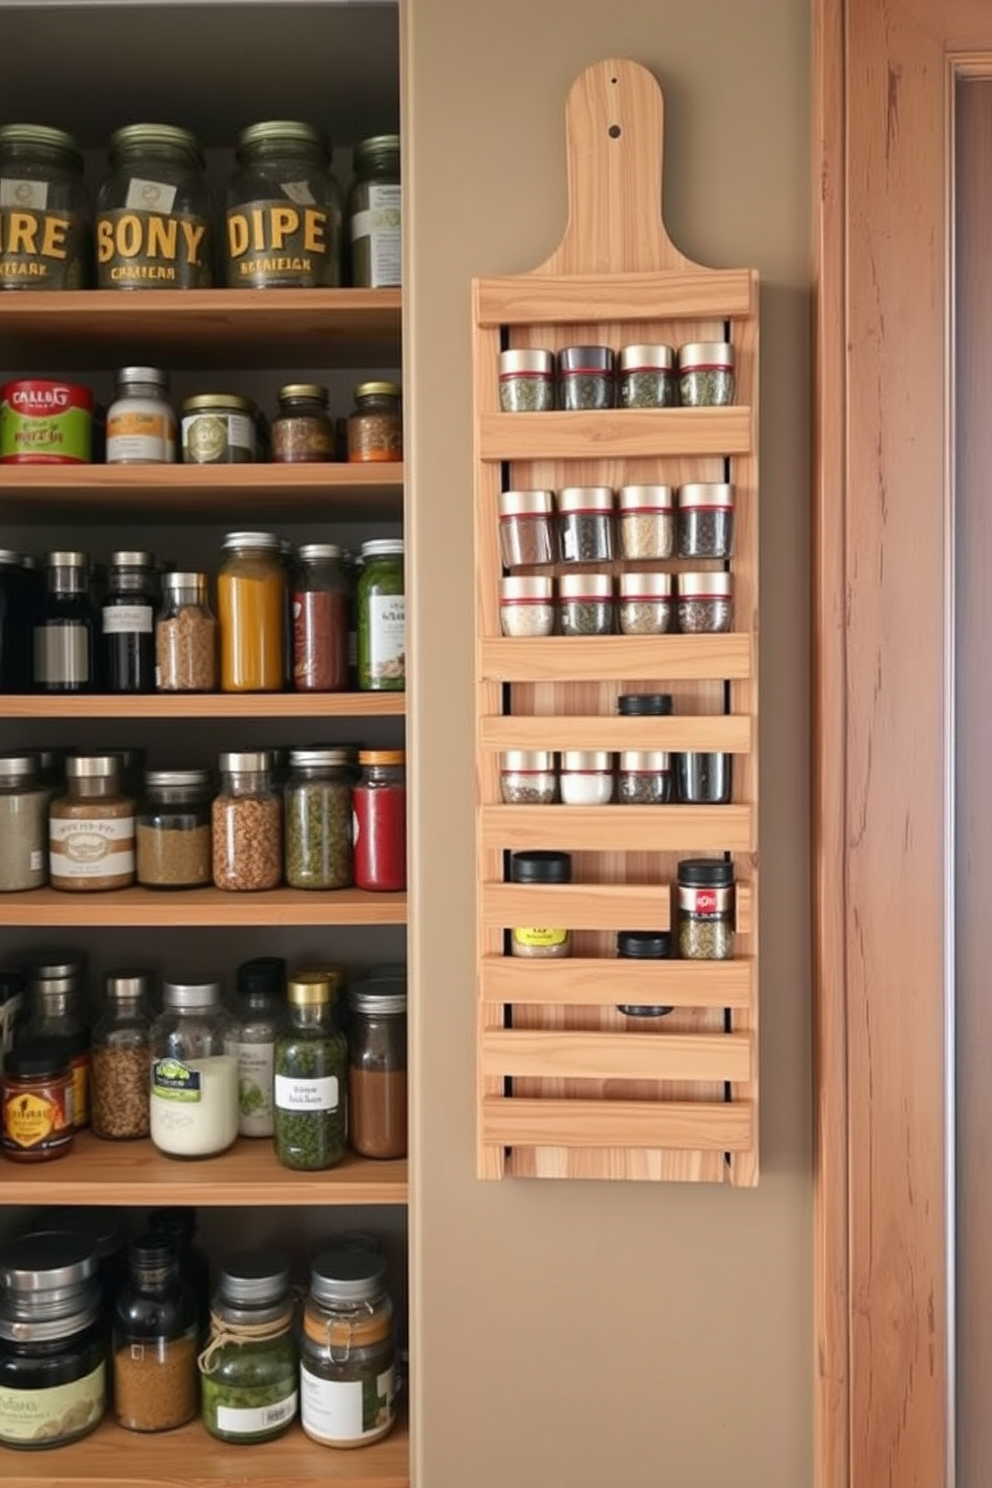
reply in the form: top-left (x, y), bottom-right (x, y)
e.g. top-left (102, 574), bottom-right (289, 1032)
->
top-left (348, 976), bottom-right (406, 1158)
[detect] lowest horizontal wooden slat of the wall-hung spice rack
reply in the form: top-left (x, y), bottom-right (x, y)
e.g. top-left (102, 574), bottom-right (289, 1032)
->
top-left (482, 1095), bottom-right (754, 1152)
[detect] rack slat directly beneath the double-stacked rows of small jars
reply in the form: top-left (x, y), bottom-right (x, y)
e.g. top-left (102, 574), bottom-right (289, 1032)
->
top-left (479, 631), bottom-right (754, 684)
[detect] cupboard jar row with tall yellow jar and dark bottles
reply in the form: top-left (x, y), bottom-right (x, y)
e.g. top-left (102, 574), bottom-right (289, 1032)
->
top-left (0, 533), bottom-right (406, 693)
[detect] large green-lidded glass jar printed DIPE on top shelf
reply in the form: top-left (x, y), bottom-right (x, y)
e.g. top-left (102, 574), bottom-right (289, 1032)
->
top-left (225, 119), bottom-right (344, 289)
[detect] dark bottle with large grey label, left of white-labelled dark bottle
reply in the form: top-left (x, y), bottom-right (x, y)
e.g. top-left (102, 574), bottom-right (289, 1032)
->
top-left (34, 552), bottom-right (97, 692)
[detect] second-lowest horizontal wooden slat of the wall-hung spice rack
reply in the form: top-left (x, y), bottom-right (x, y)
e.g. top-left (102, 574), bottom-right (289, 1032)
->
top-left (482, 1028), bottom-right (753, 1080)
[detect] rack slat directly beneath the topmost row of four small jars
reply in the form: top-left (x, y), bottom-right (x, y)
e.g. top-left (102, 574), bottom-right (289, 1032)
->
top-left (476, 405), bottom-right (754, 461)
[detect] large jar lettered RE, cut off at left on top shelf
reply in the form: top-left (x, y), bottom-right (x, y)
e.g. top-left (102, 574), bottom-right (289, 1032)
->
top-left (0, 124), bottom-right (92, 289)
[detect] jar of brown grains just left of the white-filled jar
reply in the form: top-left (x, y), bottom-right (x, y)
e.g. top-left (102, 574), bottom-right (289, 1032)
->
top-left (91, 972), bottom-right (152, 1141)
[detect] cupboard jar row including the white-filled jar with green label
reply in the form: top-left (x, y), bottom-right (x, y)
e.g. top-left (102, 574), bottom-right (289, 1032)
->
top-left (0, 951), bottom-right (406, 1173)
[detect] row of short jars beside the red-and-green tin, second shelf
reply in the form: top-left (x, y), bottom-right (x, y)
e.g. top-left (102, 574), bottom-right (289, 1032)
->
top-left (0, 366), bottom-right (403, 466)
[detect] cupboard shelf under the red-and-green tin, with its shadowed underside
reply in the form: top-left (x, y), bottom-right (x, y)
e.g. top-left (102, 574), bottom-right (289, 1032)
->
top-left (0, 464), bottom-right (403, 524)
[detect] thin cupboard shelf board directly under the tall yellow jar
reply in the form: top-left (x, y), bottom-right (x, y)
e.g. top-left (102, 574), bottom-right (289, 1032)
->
top-left (0, 692), bottom-right (406, 722)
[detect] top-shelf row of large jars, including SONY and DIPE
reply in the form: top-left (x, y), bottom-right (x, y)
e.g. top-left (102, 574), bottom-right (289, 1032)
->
top-left (0, 119), bottom-right (402, 290)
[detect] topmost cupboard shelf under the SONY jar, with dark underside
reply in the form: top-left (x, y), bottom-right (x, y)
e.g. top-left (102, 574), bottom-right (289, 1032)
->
top-left (0, 289), bottom-right (402, 375)
